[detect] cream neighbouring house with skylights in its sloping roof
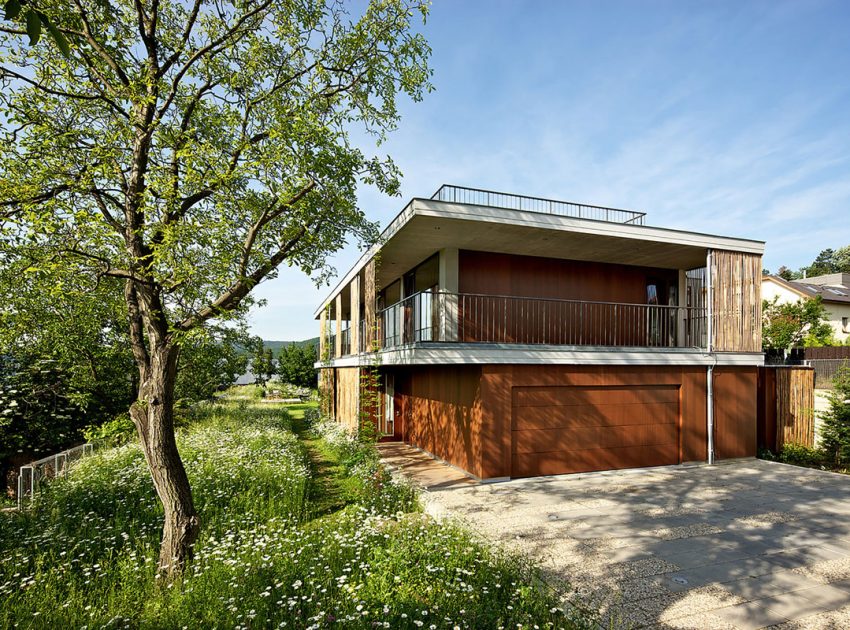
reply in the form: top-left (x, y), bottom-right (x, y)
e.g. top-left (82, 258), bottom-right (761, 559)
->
top-left (761, 273), bottom-right (850, 343)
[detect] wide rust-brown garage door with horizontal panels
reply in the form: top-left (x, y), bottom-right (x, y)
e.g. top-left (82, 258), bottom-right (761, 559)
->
top-left (511, 385), bottom-right (679, 477)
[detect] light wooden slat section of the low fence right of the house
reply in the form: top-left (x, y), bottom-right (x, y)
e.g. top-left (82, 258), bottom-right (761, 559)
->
top-left (776, 367), bottom-right (815, 452)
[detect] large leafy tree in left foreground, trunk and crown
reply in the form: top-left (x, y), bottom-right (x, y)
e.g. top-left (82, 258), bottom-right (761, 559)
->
top-left (0, 0), bottom-right (430, 577)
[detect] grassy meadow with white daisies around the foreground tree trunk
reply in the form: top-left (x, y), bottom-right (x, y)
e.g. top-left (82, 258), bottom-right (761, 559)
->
top-left (0, 402), bottom-right (587, 628)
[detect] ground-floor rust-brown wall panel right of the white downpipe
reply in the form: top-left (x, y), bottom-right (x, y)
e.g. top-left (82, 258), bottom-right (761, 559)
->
top-left (714, 367), bottom-right (758, 459)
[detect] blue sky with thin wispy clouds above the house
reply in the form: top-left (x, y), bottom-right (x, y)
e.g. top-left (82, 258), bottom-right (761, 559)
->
top-left (251, 0), bottom-right (850, 340)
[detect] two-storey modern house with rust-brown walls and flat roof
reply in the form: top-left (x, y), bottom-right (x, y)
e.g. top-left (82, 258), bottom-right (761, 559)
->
top-left (315, 186), bottom-right (764, 480)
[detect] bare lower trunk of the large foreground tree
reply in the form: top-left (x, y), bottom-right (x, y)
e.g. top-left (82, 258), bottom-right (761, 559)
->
top-left (130, 343), bottom-right (200, 579)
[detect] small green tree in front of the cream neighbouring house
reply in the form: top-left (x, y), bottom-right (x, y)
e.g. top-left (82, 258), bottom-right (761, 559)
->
top-left (762, 296), bottom-right (832, 350)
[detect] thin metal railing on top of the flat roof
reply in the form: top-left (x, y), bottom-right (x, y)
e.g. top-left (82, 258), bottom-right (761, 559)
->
top-left (431, 185), bottom-right (646, 225)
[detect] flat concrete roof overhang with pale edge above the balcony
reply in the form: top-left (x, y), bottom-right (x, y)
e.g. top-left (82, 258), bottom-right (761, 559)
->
top-left (314, 199), bottom-right (764, 317)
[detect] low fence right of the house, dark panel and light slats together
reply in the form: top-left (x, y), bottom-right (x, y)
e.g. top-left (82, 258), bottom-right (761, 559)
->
top-left (757, 365), bottom-right (815, 453)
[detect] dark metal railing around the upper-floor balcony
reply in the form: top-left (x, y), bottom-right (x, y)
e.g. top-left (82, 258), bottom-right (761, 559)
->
top-left (378, 291), bottom-right (706, 348)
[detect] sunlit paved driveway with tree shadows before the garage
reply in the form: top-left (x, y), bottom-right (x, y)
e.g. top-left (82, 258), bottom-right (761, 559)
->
top-left (426, 459), bottom-right (850, 630)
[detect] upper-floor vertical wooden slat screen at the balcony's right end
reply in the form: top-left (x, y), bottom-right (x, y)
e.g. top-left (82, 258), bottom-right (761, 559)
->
top-left (711, 251), bottom-right (762, 352)
